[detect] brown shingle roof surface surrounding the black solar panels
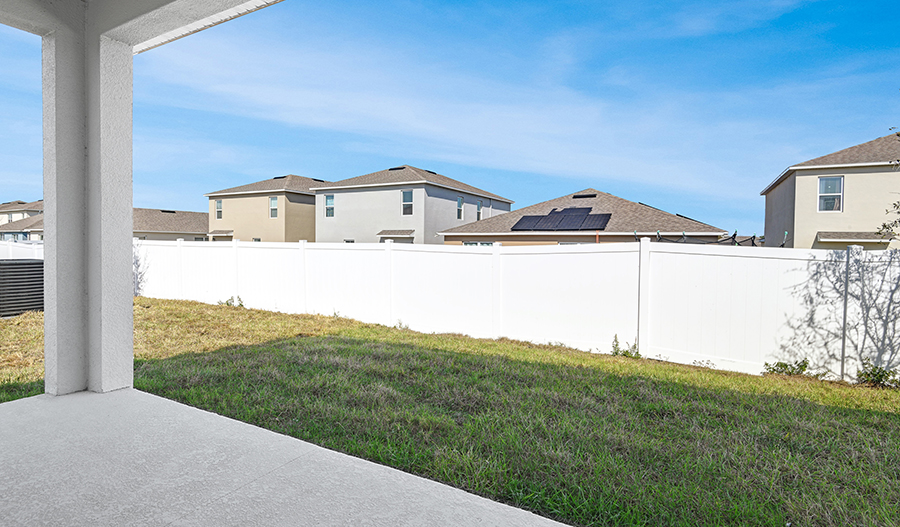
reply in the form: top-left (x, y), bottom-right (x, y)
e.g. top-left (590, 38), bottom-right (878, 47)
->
top-left (442, 188), bottom-right (724, 235)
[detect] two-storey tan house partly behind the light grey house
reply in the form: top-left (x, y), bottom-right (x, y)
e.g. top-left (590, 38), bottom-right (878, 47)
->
top-left (206, 175), bottom-right (328, 242)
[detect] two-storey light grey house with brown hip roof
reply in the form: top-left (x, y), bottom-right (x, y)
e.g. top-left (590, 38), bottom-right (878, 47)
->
top-left (315, 165), bottom-right (513, 244)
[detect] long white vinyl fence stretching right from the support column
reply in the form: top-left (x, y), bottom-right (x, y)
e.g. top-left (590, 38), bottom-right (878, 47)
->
top-left (137, 240), bottom-right (900, 378)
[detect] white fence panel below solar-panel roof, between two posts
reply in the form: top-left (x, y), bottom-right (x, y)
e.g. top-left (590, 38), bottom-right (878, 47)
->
top-left (500, 243), bottom-right (639, 352)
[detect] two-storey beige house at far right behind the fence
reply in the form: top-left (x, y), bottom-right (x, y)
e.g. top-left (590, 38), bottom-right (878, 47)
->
top-left (760, 134), bottom-right (900, 249)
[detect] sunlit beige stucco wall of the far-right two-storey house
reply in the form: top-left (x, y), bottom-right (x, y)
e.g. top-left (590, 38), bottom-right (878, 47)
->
top-left (788, 167), bottom-right (900, 249)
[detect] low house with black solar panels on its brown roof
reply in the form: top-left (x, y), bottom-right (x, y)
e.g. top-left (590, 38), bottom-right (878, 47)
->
top-left (440, 188), bottom-right (728, 245)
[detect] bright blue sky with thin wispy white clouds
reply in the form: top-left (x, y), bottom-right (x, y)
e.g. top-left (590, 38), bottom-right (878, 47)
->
top-left (0, 0), bottom-right (900, 234)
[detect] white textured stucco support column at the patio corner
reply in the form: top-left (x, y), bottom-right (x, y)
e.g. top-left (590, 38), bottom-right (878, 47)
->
top-left (43, 8), bottom-right (133, 395)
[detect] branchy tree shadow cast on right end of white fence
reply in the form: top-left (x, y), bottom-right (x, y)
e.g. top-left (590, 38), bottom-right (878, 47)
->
top-left (779, 249), bottom-right (900, 378)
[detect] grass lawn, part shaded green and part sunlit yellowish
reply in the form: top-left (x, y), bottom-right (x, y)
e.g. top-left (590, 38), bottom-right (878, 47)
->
top-left (0, 298), bottom-right (900, 527)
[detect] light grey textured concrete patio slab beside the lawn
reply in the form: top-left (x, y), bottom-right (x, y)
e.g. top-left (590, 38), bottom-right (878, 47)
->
top-left (0, 389), bottom-right (560, 527)
